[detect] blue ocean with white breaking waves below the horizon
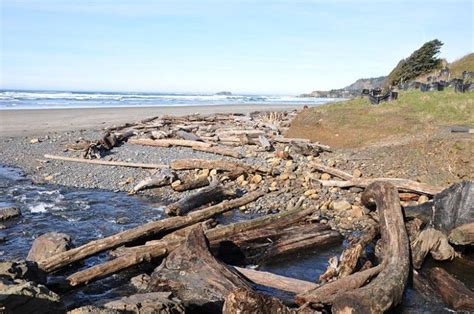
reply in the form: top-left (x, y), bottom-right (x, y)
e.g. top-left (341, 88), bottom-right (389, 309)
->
top-left (0, 90), bottom-right (340, 110)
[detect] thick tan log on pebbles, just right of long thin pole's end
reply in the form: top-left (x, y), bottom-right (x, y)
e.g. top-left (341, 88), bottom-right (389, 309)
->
top-left (170, 159), bottom-right (269, 173)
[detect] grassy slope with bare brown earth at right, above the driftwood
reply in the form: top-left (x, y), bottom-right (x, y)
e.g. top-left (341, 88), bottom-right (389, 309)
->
top-left (287, 89), bottom-right (474, 147)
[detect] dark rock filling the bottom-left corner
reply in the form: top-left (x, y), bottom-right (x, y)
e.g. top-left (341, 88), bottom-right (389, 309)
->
top-left (0, 278), bottom-right (65, 313)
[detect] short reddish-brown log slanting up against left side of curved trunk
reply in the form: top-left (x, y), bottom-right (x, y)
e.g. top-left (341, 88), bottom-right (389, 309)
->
top-left (295, 265), bottom-right (383, 306)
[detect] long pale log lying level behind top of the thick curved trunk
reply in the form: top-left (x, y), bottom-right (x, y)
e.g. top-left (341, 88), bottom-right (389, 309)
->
top-left (319, 178), bottom-right (442, 195)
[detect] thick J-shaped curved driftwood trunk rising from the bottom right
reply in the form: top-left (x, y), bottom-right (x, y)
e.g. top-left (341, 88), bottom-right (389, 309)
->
top-left (332, 182), bottom-right (410, 313)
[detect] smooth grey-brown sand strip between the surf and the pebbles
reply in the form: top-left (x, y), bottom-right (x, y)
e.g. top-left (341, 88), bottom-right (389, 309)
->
top-left (0, 104), bottom-right (301, 137)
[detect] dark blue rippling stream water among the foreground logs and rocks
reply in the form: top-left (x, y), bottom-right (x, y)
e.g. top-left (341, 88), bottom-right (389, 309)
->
top-left (0, 166), bottom-right (460, 313)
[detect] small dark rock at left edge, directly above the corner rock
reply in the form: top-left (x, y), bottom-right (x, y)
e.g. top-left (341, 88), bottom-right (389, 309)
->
top-left (0, 261), bottom-right (46, 283)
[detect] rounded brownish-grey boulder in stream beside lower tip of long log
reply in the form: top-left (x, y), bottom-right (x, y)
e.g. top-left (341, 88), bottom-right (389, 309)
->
top-left (26, 232), bottom-right (72, 262)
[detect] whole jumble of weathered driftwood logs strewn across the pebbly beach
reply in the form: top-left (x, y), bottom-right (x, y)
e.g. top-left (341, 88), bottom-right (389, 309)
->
top-left (39, 113), bottom-right (474, 313)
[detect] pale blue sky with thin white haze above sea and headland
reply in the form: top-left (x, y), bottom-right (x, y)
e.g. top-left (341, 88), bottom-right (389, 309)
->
top-left (0, 0), bottom-right (474, 94)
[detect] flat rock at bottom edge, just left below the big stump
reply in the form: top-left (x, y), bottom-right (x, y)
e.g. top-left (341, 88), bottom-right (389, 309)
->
top-left (104, 292), bottom-right (185, 313)
